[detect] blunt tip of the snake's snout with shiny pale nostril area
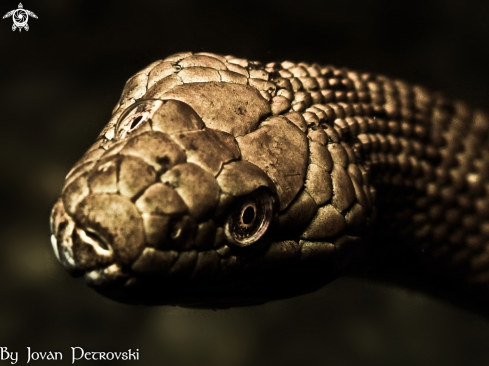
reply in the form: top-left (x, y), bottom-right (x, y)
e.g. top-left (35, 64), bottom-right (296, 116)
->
top-left (51, 194), bottom-right (145, 275)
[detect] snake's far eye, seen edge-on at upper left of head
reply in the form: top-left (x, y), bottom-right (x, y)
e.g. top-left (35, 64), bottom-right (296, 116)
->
top-left (116, 99), bottom-right (163, 140)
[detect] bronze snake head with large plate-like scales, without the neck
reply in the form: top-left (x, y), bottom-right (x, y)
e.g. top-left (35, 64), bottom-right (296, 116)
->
top-left (51, 56), bottom-right (370, 307)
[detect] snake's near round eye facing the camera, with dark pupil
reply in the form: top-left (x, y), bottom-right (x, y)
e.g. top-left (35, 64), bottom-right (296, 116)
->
top-left (224, 188), bottom-right (273, 247)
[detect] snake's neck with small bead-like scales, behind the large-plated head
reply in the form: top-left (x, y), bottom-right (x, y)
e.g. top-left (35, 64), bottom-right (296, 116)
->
top-left (269, 64), bottom-right (489, 291)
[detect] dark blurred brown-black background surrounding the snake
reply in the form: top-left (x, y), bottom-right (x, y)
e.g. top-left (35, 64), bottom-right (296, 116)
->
top-left (0, 0), bottom-right (489, 366)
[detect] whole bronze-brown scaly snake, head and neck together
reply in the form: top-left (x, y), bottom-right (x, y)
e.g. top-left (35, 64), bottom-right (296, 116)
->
top-left (50, 52), bottom-right (489, 308)
